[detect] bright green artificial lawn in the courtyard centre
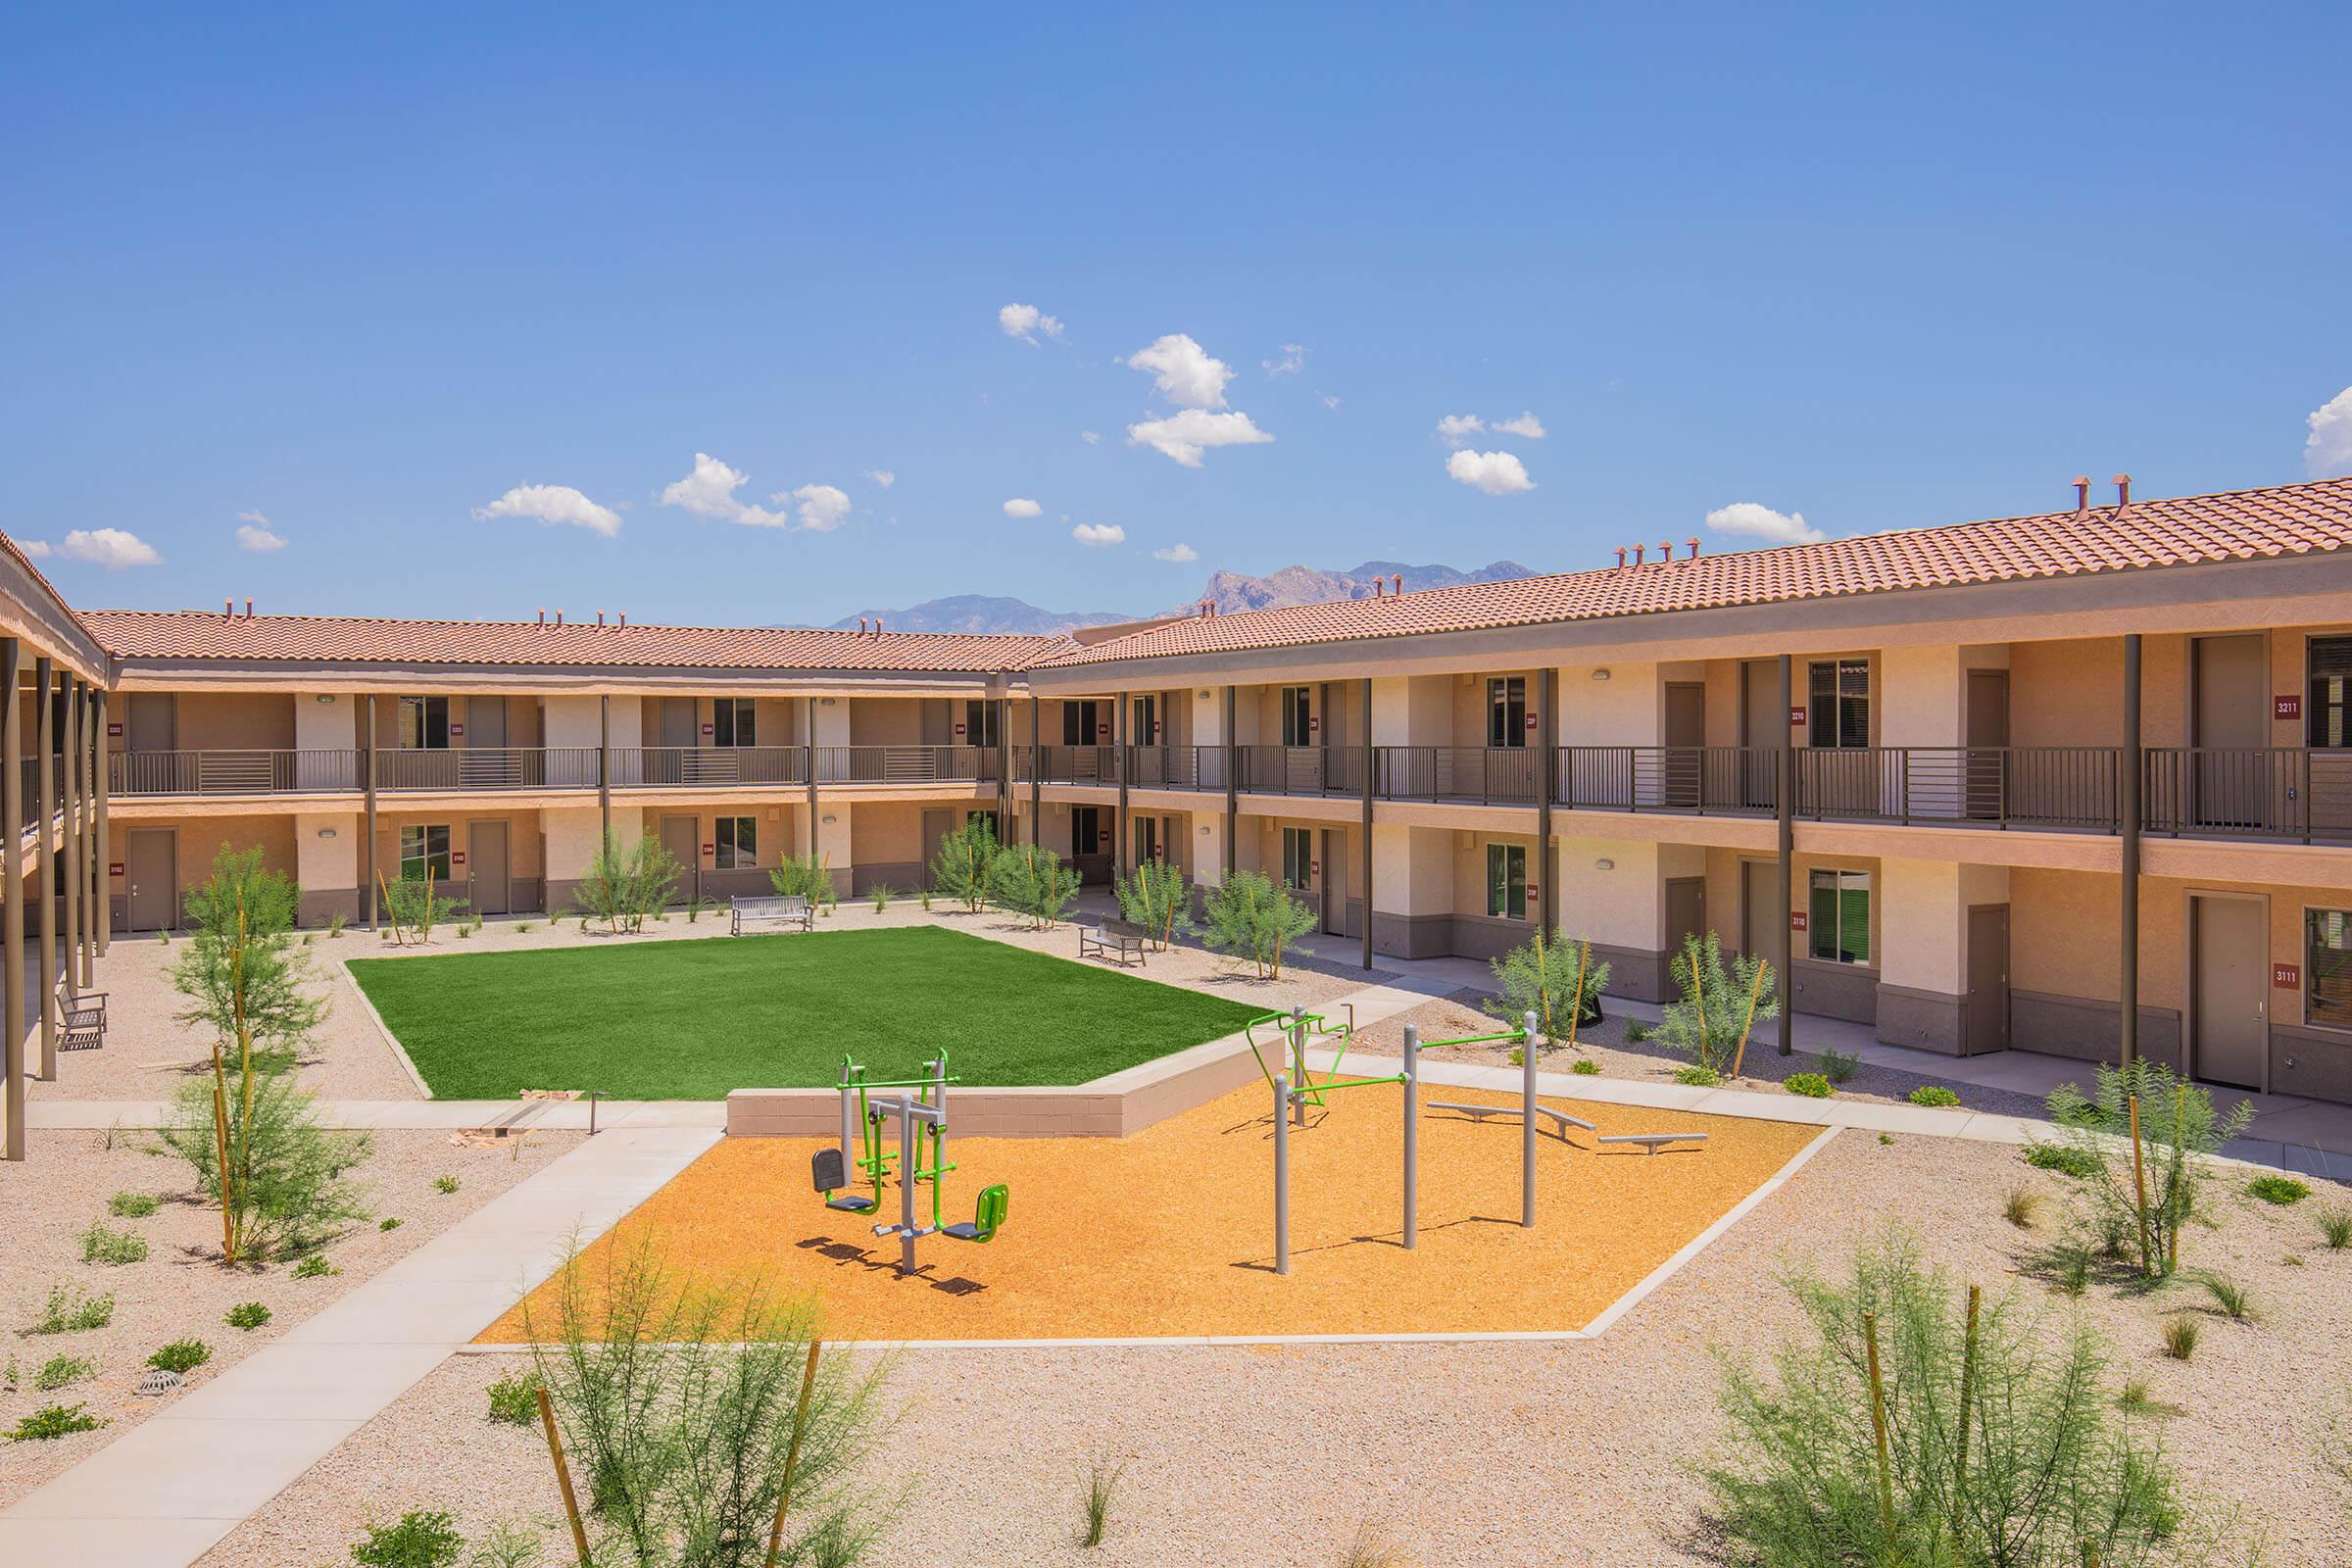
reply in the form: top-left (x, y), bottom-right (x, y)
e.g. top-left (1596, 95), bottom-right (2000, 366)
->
top-left (351, 926), bottom-right (1258, 1101)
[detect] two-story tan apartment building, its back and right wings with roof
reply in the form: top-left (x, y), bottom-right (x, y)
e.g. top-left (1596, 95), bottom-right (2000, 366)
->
top-left (4, 479), bottom-right (2352, 1152)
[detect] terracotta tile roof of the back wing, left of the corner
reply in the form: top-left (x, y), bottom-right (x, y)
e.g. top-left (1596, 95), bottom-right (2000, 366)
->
top-left (82, 609), bottom-right (1063, 674)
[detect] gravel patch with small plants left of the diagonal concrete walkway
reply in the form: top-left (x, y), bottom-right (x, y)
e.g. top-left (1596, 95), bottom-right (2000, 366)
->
top-left (0, 1128), bottom-right (581, 1504)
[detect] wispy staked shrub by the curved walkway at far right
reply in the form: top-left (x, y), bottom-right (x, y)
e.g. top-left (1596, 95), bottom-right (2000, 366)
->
top-left (2048, 1057), bottom-right (2253, 1279)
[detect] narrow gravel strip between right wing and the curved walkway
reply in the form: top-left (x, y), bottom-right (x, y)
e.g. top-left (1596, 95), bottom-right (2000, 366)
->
top-left (1352, 990), bottom-right (2048, 1116)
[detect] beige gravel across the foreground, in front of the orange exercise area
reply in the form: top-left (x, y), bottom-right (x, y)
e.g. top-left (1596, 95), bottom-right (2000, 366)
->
top-left (202, 1133), bottom-right (2352, 1568)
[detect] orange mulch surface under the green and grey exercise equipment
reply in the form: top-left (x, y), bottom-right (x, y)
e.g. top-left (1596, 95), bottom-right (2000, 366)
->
top-left (482, 1084), bottom-right (1818, 1343)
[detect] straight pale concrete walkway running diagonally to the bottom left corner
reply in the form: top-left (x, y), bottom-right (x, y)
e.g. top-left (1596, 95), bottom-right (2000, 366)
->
top-left (0, 1128), bottom-right (717, 1568)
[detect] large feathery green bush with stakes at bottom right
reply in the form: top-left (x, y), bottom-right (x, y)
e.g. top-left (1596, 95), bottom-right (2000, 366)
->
top-left (1698, 1232), bottom-right (2187, 1568)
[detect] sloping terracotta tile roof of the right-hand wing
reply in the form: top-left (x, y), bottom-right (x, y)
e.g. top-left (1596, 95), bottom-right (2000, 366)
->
top-left (1030, 479), bottom-right (2352, 667)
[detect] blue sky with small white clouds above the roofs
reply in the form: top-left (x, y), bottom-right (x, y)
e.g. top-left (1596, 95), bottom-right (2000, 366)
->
top-left (0, 5), bottom-right (2352, 623)
